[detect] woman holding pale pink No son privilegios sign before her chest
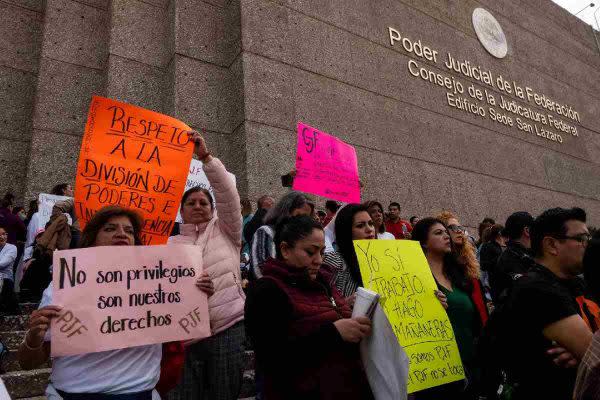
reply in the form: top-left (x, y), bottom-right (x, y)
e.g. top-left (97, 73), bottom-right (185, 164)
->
top-left (18, 206), bottom-right (162, 400)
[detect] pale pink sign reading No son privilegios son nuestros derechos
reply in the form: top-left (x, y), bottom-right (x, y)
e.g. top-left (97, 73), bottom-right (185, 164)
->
top-left (50, 245), bottom-right (210, 356)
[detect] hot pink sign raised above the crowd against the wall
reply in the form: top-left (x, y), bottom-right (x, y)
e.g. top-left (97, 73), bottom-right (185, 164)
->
top-left (293, 122), bottom-right (360, 203)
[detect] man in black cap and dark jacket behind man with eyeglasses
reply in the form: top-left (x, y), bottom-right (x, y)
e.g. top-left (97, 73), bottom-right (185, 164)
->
top-left (488, 211), bottom-right (534, 301)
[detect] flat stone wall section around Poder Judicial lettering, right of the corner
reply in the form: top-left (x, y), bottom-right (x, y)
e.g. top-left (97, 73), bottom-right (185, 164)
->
top-left (237, 0), bottom-right (600, 227)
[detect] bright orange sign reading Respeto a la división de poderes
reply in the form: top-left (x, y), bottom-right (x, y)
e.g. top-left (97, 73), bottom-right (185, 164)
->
top-left (75, 96), bottom-right (194, 245)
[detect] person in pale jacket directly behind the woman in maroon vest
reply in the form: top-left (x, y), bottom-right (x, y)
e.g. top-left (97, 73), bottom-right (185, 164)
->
top-left (250, 192), bottom-right (315, 279)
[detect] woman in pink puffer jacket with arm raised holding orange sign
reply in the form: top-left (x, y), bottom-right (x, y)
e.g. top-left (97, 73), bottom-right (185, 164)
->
top-left (168, 133), bottom-right (246, 400)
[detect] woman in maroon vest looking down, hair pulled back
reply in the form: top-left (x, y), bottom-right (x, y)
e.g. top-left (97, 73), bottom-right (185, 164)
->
top-left (246, 216), bottom-right (373, 400)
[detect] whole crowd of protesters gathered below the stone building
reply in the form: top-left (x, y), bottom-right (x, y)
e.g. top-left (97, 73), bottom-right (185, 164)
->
top-left (0, 133), bottom-right (600, 400)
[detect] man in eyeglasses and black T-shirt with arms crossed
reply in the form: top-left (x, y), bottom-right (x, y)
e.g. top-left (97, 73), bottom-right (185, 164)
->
top-left (496, 208), bottom-right (592, 400)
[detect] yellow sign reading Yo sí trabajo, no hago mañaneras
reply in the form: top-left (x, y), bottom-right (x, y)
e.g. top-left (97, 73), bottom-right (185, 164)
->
top-left (354, 240), bottom-right (465, 393)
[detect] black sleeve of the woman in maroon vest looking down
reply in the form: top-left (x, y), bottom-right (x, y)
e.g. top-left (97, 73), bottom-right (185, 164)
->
top-left (245, 279), bottom-right (344, 369)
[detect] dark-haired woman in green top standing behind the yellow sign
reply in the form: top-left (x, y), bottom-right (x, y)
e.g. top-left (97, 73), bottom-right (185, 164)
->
top-left (412, 218), bottom-right (487, 400)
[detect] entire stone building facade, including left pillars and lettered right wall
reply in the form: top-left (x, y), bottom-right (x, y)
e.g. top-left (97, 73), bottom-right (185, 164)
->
top-left (0, 0), bottom-right (600, 230)
